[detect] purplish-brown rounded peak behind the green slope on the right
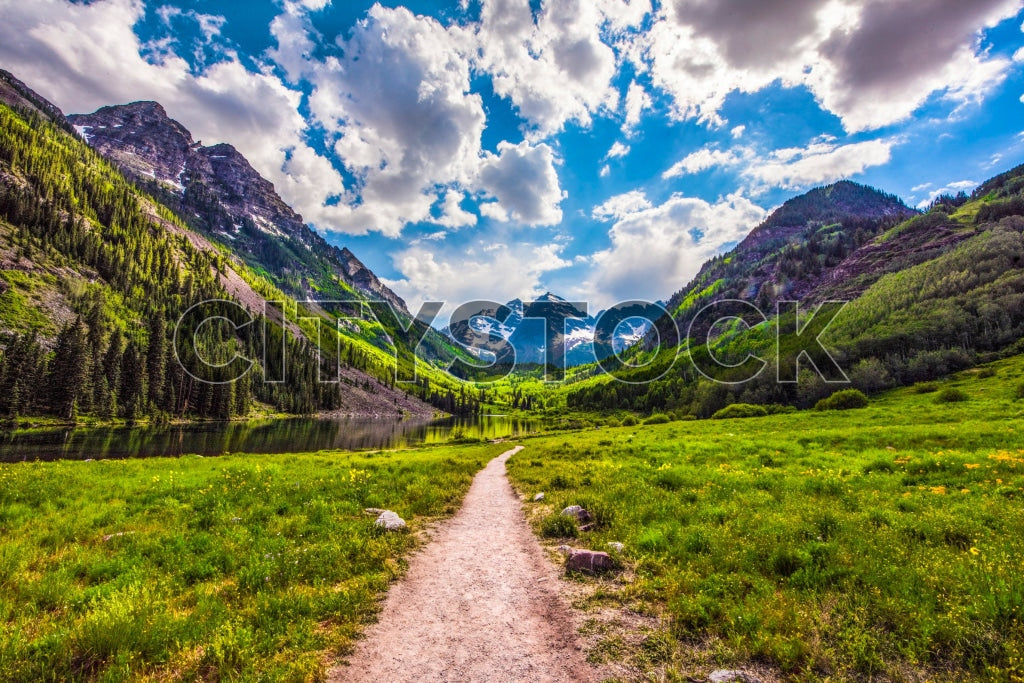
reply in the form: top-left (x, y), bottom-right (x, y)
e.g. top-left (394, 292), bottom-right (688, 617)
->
top-left (669, 180), bottom-right (918, 334)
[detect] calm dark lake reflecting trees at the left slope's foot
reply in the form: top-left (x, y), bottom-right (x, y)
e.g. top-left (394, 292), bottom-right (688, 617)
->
top-left (0, 416), bottom-right (540, 463)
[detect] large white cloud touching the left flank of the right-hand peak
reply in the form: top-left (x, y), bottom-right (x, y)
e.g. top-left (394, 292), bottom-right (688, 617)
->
top-left (584, 193), bottom-right (766, 306)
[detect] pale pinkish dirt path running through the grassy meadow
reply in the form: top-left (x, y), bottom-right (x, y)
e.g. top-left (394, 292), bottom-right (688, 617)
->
top-left (331, 446), bottom-right (594, 682)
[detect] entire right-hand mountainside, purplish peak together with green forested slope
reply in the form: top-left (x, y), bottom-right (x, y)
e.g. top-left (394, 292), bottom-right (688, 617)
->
top-left (565, 166), bottom-right (1024, 417)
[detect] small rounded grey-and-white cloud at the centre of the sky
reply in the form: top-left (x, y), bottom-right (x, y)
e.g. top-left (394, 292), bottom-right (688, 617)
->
top-left (479, 141), bottom-right (566, 225)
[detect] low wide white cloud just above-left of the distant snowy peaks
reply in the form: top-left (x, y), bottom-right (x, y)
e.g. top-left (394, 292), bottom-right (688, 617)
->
top-left (385, 243), bottom-right (572, 311)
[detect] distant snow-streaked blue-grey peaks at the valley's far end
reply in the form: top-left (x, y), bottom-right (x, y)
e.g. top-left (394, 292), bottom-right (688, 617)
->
top-left (446, 292), bottom-right (650, 368)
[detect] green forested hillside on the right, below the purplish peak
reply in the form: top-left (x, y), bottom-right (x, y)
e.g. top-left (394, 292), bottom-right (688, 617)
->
top-left (564, 167), bottom-right (1024, 417)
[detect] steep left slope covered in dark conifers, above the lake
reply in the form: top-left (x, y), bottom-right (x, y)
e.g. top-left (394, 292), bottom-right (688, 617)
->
top-left (0, 74), bottom-right (448, 420)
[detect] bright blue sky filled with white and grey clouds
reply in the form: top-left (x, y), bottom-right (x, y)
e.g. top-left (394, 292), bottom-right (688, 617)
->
top-left (0, 0), bottom-right (1024, 311)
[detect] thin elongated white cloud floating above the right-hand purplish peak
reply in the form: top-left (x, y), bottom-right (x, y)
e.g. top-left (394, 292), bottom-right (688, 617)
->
top-left (662, 139), bottom-right (898, 194)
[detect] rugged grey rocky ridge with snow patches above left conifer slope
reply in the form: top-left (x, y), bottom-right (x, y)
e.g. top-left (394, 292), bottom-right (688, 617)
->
top-left (68, 101), bottom-right (408, 313)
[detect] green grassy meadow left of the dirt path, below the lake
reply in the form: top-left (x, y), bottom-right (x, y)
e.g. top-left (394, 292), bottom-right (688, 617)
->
top-left (0, 444), bottom-right (503, 681)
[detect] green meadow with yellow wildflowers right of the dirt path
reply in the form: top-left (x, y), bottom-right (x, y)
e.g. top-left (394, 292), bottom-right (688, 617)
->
top-left (510, 358), bottom-right (1024, 680)
